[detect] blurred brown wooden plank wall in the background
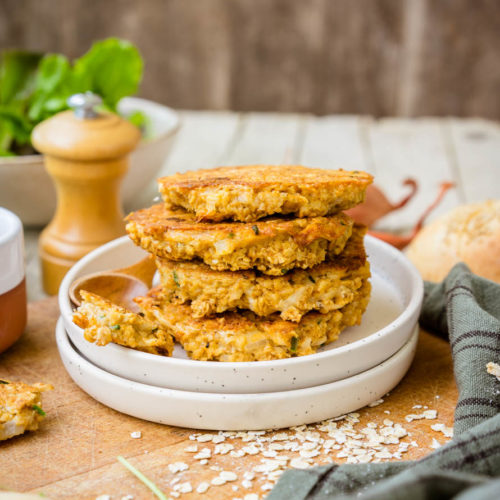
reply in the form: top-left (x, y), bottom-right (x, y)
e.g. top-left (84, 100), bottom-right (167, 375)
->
top-left (0, 0), bottom-right (500, 119)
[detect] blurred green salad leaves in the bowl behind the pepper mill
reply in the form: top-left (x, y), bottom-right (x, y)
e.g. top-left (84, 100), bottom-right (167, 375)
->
top-left (0, 38), bottom-right (148, 156)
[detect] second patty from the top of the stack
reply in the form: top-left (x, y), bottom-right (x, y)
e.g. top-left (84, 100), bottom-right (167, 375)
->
top-left (126, 204), bottom-right (353, 276)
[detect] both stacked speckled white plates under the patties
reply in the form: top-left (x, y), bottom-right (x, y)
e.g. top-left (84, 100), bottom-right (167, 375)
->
top-left (56, 236), bottom-right (423, 430)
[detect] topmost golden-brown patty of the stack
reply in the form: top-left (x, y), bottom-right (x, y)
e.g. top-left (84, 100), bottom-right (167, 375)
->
top-left (158, 165), bottom-right (373, 222)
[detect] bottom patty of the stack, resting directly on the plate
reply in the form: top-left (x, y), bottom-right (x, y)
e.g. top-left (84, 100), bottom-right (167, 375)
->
top-left (135, 281), bottom-right (370, 361)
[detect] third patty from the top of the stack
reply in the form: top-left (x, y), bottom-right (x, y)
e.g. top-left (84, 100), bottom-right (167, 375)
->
top-left (157, 226), bottom-right (370, 321)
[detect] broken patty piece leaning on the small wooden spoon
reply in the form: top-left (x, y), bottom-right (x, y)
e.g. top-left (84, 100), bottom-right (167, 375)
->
top-left (73, 290), bottom-right (174, 356)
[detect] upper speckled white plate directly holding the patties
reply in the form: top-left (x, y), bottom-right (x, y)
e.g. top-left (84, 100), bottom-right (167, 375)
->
top-left (59, 236), bottom-right (423, 393)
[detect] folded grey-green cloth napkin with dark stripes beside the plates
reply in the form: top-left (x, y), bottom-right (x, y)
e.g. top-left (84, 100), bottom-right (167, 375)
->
top-left (267, 264), bottom-right (500, 500)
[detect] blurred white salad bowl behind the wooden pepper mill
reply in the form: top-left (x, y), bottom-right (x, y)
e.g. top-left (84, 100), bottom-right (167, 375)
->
top-left (0, 97), bottom-right (179, 226)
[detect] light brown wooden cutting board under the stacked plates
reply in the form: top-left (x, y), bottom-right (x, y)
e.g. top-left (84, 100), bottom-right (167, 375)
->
top-left (0, 298), bottom-right (457, 500)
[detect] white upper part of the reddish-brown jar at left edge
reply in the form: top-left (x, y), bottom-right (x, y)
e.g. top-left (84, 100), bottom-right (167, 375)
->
top-left (0, 207), bottom-right (24, 295)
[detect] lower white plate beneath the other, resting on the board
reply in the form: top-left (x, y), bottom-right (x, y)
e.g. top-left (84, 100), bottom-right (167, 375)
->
top-left (56, 319), bottom-right (418, 430)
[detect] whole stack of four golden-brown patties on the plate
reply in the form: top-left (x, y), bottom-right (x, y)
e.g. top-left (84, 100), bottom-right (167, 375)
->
top-left (127, 165), bottom-right (372, 361)
